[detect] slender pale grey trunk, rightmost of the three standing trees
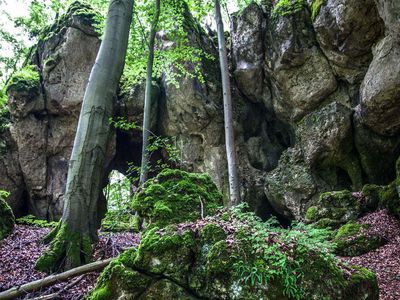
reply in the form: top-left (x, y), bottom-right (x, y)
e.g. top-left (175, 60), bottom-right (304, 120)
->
top-left (214, 0), bottom-right (240, 205)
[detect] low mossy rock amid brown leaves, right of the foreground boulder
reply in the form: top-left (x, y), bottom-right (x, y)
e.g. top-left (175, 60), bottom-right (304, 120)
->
top-left (334, 222), bottom-right (386, 256)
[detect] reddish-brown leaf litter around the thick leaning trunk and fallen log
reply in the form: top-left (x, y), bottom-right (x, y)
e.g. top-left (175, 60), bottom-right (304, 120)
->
top-left (0, 225), bottom-right (140, 300)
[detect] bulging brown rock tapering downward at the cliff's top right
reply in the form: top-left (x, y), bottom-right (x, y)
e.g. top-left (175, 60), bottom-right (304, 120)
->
top-left (313, 0), bottom-right (383, 83)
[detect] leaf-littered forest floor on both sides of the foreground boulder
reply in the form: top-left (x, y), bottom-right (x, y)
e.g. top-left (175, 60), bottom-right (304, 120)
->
top-left (0, 211), bottom-right (400, 300)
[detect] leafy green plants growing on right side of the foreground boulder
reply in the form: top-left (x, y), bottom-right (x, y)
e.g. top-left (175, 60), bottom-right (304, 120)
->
top-left (234, 205), bottom-right (340, 299)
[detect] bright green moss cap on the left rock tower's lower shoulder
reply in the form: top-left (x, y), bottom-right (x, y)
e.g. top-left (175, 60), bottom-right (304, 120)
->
top-left (6, 66), bottom-right (40, 93)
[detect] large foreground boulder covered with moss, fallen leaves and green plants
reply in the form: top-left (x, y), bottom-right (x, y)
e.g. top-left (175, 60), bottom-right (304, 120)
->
top-left (89, 209), bottom-right (378, 300)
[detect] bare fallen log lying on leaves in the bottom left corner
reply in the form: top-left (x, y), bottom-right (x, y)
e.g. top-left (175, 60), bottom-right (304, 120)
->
top-left (0, 258), bottom-right (112, 300)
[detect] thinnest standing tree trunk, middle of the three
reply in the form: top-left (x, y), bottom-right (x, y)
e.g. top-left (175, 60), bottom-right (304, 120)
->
top-left (139, 0), bottom-right (160, 185)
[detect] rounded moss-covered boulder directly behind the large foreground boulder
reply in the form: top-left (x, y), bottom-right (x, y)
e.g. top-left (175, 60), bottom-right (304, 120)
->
top-left (133, 169), bottom-right (223, 227)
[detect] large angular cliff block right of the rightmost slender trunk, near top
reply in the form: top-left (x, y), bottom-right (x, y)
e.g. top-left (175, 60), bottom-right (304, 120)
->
top-left (265, 10), bottom-right (337, 121)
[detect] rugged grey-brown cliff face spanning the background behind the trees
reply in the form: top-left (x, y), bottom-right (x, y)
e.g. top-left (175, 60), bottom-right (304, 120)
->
top-left (0, 0), bottom-right (400, 219)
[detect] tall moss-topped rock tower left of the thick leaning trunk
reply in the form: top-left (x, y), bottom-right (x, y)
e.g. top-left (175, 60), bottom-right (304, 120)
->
top-left (0, 2), bottom-right (100, 219)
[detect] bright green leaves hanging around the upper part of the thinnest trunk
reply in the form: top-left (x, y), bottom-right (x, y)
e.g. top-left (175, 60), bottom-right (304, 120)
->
top-left (122, 0), bottom-right (214, 90)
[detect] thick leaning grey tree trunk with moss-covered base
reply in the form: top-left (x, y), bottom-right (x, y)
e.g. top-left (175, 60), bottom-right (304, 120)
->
top-left (36, 0), bottom-right (133, 271)
